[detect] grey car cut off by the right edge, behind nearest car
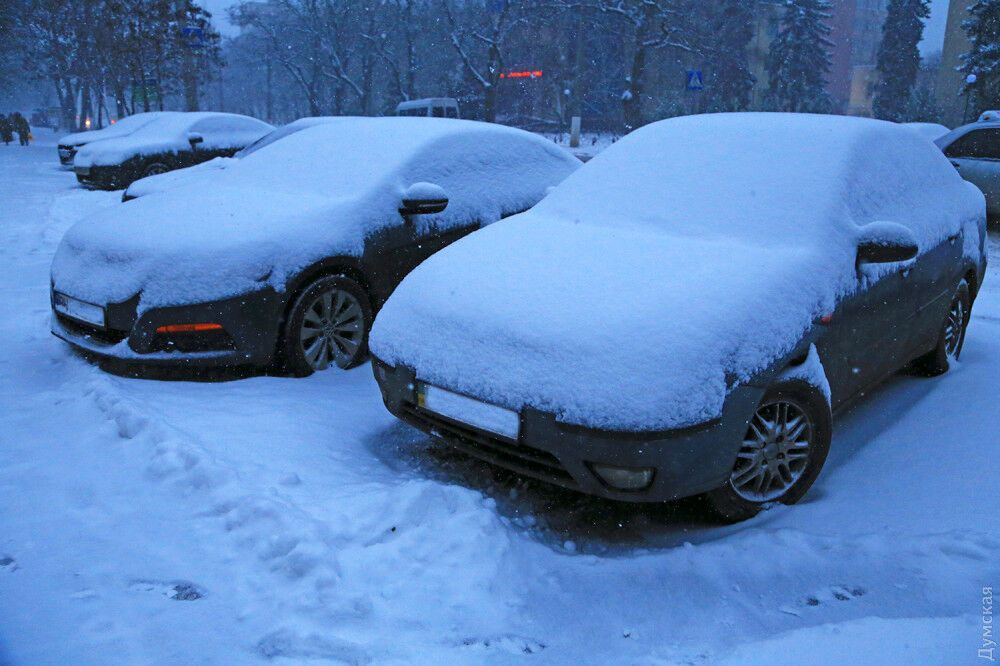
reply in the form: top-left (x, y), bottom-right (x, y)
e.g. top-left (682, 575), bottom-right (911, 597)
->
top-left (934, 120), bottom-right (1000, 218)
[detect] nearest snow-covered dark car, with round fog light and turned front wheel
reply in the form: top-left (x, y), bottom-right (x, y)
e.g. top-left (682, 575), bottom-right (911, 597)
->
top-left (371, 114), bottom-right (986, 520)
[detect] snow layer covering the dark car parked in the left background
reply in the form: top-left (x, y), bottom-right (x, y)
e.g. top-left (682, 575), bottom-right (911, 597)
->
top-left (73, 111), bottom-right (274, 167)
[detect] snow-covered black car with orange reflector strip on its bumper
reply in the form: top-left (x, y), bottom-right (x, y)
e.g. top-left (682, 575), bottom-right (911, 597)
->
top-left (52, 118), bottom-right (580, 375)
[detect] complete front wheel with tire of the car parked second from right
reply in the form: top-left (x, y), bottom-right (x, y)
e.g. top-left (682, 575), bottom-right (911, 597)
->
top-left (279, 275), bottom-right (372, 377)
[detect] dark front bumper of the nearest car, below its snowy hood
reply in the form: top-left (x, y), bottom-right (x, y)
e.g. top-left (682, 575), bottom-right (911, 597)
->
top-left (372, 357), bottom-right (765, 502)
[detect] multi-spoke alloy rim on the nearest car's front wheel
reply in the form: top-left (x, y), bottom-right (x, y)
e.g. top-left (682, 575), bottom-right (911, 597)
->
top-left (729, 398), bottom-right (815, 502)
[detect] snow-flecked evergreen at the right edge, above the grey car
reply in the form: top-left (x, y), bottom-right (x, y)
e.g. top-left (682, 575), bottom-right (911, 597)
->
top-left (961, 0), bottom-right (1000, 114)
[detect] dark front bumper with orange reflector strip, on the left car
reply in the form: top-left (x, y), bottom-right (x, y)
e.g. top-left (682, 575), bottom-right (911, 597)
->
top-left (51, 289), bottom-right (283, 367)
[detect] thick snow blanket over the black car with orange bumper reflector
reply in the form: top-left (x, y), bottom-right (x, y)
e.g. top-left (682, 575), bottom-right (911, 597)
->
top-left (52, 118), bottom-right (579, 309)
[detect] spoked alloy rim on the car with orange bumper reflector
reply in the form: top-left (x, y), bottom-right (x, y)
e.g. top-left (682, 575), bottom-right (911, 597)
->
top-left (299, 288), bottom-right (364, 370)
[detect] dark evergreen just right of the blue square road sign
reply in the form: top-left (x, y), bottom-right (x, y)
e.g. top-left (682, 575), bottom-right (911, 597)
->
top-left (705, 0), bottom-right (756, 112)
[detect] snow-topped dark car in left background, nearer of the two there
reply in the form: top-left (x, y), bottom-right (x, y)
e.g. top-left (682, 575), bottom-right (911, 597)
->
top-left (73, 111), bottom-right (274, 190)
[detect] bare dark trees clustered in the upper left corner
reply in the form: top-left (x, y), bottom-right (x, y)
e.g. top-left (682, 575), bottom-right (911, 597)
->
top-left (3, 0), bottom-right (220, 127)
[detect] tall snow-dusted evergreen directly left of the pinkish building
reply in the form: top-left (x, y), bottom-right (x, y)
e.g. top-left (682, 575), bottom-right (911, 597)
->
top-left (767, 0), bottom-right (833, 113)
